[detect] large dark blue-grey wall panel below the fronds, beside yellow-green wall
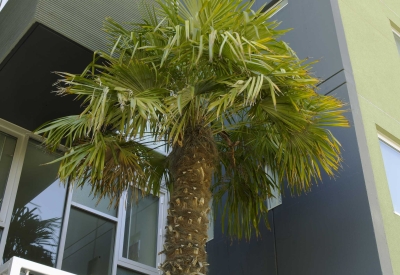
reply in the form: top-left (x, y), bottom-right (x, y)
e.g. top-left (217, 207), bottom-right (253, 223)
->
top-left (274, 85), bottom-right (382, 275)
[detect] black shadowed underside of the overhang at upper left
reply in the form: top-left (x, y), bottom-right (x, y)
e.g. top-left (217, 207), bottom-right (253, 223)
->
top-left (0, 24), bottom-right (93, 130)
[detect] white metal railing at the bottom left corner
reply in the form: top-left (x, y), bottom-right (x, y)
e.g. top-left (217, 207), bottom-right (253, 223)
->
top-left (0, 257), bottom-right (75, 275)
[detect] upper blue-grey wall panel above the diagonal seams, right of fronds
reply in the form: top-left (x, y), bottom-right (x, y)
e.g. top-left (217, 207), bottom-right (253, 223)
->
top-left (272, 0), bottom-right (343, 80)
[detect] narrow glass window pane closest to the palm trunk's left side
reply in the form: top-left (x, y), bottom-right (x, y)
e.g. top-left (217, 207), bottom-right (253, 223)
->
top-left (122, 195), bottom-right (159, 267)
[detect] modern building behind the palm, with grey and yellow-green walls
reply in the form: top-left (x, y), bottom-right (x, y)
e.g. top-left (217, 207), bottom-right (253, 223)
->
top-left (0, 0), bottom-right (400, 275)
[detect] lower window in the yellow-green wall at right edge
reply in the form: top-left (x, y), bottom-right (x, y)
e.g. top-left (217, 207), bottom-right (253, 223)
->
top-left (379, 134), bottom-right (400, 215)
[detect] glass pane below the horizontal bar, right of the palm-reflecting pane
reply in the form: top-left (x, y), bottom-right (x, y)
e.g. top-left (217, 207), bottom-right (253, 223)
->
top-left (62, 207), bottom-right (116, 275)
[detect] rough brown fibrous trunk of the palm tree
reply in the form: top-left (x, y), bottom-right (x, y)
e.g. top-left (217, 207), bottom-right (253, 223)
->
top-left (161, 126), bottom-right (216, 275)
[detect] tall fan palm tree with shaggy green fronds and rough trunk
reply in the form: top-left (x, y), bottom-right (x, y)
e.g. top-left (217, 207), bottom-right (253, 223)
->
top-left (37, 0), bottom-right (348, 275)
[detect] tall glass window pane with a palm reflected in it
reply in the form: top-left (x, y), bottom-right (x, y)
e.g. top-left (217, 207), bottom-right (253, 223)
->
top-left (3, 140), bottom-right (66, 266)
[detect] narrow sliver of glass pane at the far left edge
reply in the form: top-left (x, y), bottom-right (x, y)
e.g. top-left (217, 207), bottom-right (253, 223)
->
top-left (0, 132), bottom-right (17, 210)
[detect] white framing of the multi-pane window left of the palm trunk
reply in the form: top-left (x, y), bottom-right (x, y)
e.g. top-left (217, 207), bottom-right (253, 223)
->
top-left (0, 119), bottom-right (169, 275)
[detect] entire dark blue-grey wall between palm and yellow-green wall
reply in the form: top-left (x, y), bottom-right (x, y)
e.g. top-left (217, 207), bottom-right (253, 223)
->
top-left (208, 0), bottom-right (382, 275)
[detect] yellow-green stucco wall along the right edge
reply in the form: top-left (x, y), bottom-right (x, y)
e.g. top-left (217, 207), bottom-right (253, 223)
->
top-left (339, 0), bottom-right (400, 275)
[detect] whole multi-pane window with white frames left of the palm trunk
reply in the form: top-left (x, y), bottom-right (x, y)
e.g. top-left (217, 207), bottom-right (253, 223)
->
top-left (0, 119), bottom-right (167, 275)
